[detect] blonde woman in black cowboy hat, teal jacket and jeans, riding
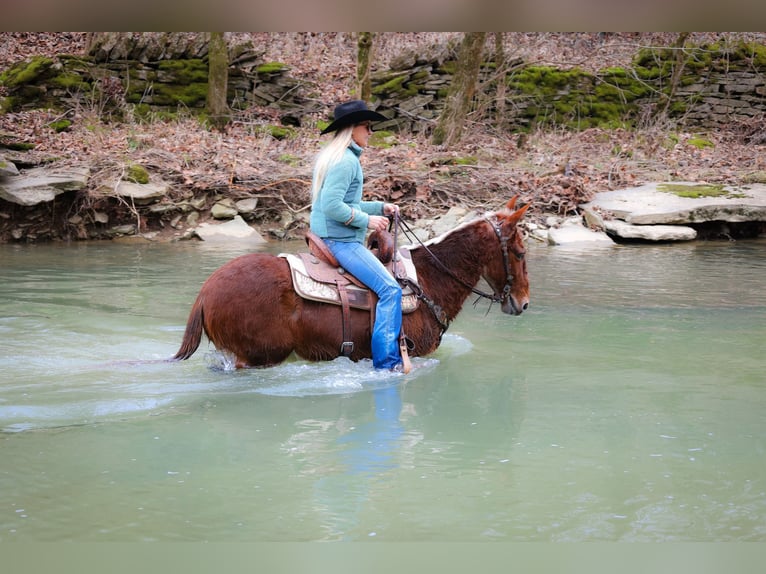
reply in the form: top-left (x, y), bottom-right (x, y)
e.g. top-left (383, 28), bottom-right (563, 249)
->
top-left (310, 100), bottom-right (402, 371)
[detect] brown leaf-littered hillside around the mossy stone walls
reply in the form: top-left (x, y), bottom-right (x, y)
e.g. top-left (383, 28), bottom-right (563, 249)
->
top-left (0, 32), bottom-right (766, 241)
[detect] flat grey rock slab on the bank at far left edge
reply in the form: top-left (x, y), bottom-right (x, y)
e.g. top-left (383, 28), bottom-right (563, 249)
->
top-left (0, 167), bottom-right (90, 206)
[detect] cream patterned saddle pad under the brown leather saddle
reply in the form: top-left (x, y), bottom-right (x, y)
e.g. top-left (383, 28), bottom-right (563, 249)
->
top-left (279, 253), bottom-right (418, 313)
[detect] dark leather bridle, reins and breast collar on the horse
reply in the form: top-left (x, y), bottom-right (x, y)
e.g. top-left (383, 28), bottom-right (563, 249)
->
top-left (393, 214), bottom-right (525, 335)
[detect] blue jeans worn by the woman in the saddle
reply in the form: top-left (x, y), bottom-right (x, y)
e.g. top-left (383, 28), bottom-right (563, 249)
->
top-left (324, 239), bottom-right (402, 369)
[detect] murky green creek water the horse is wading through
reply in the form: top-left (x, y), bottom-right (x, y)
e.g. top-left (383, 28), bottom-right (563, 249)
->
top-left (0, 236), bottom-right (766, 541)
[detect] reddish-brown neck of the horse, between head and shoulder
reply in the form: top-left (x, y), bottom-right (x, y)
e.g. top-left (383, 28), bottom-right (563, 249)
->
top-left (412, 221), bottom-right (492, 318)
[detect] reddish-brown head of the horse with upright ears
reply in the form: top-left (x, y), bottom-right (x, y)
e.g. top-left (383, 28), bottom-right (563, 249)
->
top-left (482, 196), bottom-right (529, 315)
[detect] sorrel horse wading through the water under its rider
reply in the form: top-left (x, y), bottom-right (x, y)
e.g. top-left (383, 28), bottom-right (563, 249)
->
top-left (173, 197), bottom-right (529, 368)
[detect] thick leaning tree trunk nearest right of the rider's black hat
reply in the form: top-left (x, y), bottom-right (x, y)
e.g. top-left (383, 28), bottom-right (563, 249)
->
top-left (431, 32), bottom-right (487, 145)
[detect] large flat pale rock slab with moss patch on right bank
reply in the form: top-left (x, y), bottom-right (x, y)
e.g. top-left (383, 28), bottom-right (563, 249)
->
top-left (582, 182), bottom-right (766, 225)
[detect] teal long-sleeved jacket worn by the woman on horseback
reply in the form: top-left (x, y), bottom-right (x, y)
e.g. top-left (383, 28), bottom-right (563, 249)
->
top-left (309, 141), bottom-right (383, 243)
